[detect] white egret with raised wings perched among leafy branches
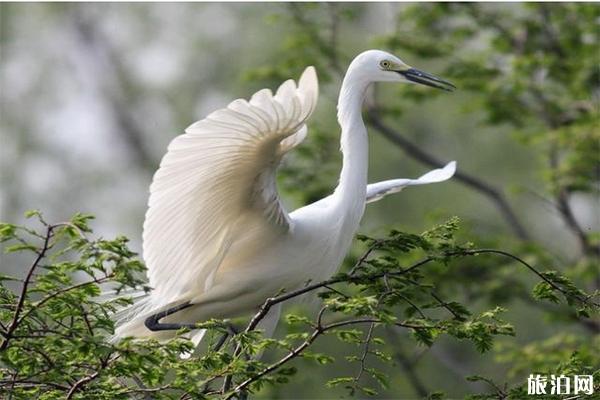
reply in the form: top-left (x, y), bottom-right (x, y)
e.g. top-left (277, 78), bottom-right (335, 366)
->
top-left (116, 50), bottom-right (455, 346)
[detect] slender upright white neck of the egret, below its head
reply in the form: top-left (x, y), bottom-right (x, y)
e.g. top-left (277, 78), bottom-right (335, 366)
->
top-left (334, 71), bottom-right (369, 225)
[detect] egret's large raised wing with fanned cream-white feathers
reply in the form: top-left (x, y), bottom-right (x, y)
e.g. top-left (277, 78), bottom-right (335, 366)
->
top-left (143, 67), bottom-right (318, 305)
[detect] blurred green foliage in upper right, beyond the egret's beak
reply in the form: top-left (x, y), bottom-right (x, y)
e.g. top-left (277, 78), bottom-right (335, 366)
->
top-left (379, 3), bottom-right (600, 200)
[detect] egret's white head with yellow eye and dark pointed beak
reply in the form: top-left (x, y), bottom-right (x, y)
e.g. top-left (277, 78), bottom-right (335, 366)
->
top-left (349, 50), bottom-right (456, 91)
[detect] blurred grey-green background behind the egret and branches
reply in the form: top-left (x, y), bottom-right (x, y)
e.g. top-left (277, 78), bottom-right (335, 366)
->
top-left (0, 3), bottom-right (600, 398)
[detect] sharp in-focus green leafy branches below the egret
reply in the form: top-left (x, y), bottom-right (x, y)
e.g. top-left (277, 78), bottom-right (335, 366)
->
top-left (0, 212), bottom-right (597, 399)
